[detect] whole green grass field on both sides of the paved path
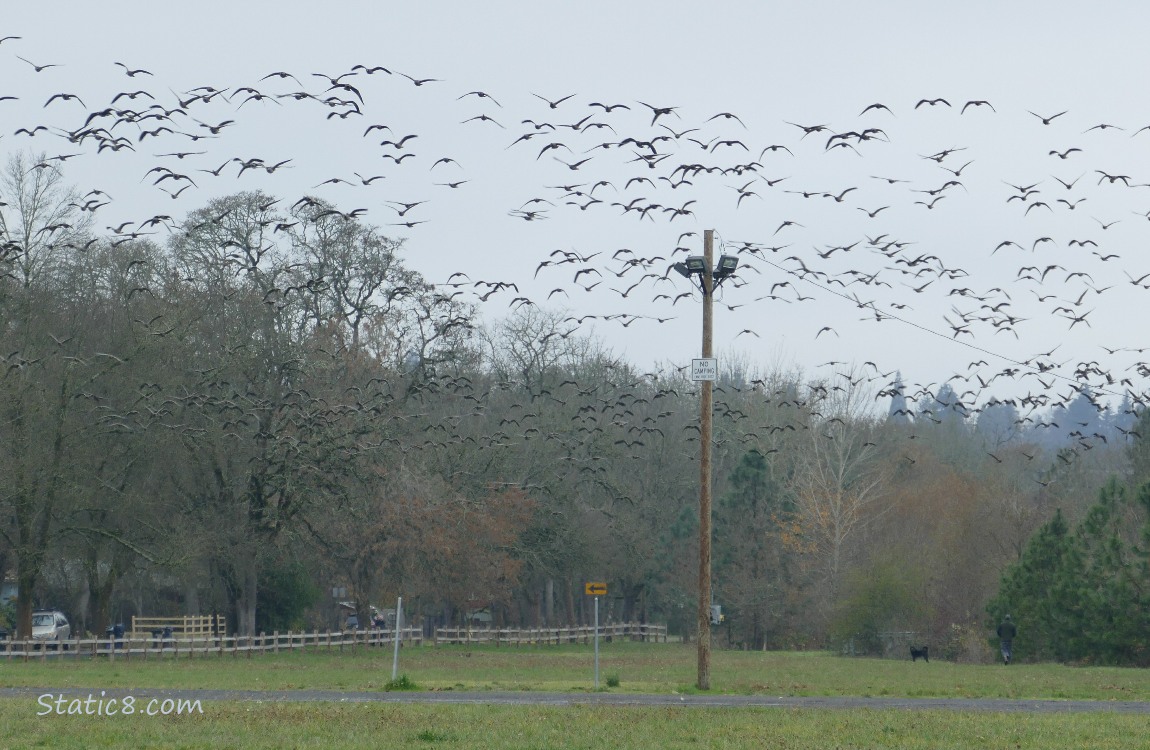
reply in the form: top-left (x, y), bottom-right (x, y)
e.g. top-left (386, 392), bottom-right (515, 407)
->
top-left (0, 643), bottom-right (1150, 750)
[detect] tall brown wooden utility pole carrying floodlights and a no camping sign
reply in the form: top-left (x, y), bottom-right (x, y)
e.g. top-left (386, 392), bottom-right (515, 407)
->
top-left (696, 229), bottom-right (714, 690)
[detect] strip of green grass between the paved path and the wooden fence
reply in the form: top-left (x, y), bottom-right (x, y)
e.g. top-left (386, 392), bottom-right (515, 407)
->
top-left (0, 643), bottom-right (1150, 701)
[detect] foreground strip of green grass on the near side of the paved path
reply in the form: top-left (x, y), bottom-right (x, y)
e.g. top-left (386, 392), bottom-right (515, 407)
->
top-left (0, 701), bottom-right (1150, 750)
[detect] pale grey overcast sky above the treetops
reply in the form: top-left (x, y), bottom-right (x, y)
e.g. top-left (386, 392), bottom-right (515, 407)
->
top-left (0, 0), bottom-right (1150, 409)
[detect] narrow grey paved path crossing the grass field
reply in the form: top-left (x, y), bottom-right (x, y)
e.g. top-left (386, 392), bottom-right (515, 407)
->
top-left (0, 688), bottom-right (1150, 714)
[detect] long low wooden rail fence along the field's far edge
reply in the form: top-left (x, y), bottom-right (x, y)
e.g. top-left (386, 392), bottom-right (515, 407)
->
top-left (0, 622), bottom-right (667, 661)
